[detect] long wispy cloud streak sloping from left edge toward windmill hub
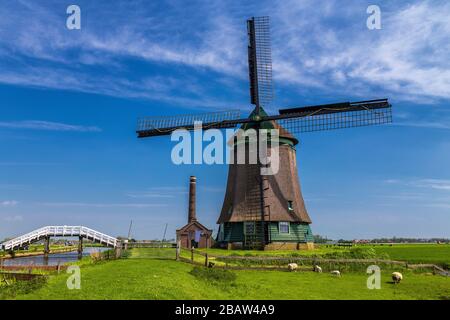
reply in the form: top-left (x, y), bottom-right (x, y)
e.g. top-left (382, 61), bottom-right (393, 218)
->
top-left (0, 64), bottom-right (242, 109)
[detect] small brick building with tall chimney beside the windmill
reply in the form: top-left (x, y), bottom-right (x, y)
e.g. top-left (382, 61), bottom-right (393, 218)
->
top-left (177, 176), bottom-right (212, 249)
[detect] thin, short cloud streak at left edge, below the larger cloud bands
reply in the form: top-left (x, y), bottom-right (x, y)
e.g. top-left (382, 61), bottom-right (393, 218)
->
top-left (0, 120), bottom-right (102, 132)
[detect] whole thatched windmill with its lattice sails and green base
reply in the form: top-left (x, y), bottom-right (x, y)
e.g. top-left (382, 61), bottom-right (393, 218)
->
top-left (137, 17), bottom-right (392, 248)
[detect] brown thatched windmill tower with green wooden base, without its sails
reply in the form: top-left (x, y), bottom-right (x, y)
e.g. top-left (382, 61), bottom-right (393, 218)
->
top-left (217, 109), bottom-right (313, 249)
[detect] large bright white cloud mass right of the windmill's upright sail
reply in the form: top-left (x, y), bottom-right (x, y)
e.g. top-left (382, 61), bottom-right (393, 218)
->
top-left (274, 0), bottom-right (450, 101)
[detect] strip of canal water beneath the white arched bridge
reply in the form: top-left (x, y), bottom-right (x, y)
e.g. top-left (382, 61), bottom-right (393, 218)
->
top-left (3, 247), bottom-right (110, 266)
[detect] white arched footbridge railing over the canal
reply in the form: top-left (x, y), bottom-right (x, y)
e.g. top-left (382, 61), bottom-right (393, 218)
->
top-left (1, 226), bottom-right (119, 250)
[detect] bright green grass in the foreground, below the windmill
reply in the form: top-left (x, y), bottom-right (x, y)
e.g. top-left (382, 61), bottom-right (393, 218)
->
top-left (7, 249), bottom-right (450, 299)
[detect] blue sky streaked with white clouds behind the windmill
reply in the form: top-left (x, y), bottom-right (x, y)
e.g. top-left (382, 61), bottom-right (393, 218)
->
top-left (0, 0), bottom-right (450, 239)
